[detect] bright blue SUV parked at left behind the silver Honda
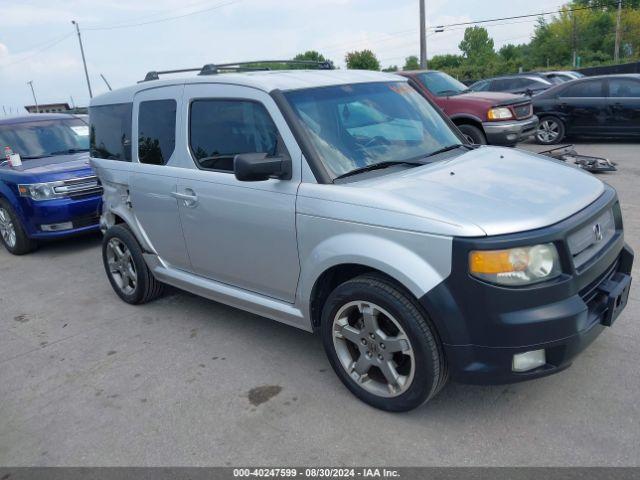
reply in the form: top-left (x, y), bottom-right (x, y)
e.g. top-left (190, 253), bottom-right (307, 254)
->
top-left (0, 114), bottom-right (102, 255)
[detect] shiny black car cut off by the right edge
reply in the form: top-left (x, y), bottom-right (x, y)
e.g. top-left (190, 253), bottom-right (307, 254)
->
top-left (533, 74), bottom-right (640, 145)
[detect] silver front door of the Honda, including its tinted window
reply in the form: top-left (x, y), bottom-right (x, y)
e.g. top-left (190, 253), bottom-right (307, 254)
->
top-left (178, 84), bottom-right (301, 303)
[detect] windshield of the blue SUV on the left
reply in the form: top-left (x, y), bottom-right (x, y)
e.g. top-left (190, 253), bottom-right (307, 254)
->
top-left (0, 117), bottom-right (89, 160)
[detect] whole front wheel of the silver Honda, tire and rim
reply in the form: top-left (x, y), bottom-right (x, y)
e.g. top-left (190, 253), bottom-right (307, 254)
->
top-left (321, 274), bottom-right (447, 412)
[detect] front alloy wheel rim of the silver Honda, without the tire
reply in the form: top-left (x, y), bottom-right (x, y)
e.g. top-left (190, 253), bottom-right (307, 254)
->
top-left (332, 301), bottom-right (415, 398)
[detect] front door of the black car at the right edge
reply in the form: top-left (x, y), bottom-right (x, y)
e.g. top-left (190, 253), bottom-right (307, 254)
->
top-left (558, 79), bottom-right (609, 134)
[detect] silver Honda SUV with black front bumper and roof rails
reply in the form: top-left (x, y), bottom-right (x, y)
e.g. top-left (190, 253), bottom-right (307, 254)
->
top-left (90, 63), bottom-right (633, 411)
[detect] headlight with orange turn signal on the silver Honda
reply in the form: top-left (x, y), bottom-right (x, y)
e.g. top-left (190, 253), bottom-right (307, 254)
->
top-left (469, 243), bottom-right (562, 286)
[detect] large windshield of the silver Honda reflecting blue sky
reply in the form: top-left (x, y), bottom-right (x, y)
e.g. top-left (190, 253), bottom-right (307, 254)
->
top-left (285, 82), bottom-right (461, 178)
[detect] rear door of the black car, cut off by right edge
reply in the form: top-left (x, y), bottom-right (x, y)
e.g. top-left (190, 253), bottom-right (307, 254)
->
top-left (608, 77), bottom-right (640, 135)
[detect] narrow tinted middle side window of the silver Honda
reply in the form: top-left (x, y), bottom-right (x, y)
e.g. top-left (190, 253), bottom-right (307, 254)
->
top-left (138, 100), bottom-right (176, 165)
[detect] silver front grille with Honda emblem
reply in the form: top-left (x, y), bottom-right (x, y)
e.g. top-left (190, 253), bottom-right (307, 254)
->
top-left (567, 209), bottom-right (616, 269)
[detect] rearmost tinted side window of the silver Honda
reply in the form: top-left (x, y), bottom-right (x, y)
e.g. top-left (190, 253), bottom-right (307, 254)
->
top-left (89, 103), bottom-right (132, 162)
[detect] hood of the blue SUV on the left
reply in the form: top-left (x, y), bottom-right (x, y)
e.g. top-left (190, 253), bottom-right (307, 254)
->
top-left (2, 152), bottom-right (92, 181)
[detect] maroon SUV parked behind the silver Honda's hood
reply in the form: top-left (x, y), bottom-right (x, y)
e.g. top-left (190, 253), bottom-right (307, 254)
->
top-left (399, 70), bottom-right (538, 146)
